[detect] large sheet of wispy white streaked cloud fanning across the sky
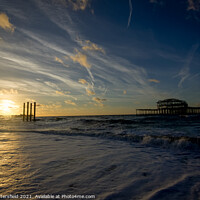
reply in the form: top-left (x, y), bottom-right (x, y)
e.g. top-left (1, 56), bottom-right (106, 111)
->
top-left (0, 0), bottom-right (170, 112)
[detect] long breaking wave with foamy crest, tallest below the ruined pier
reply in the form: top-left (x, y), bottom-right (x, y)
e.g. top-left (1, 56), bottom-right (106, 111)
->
top-left (0, 128), bottom-right (200, 151)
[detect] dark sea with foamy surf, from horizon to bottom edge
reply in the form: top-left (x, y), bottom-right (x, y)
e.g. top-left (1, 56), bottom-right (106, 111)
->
top-left (0, 115), bottom-right (200, 200)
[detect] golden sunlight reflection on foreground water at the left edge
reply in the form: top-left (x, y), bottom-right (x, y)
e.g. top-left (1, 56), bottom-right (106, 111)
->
top-left (0, 133), bottom-right (29, 195)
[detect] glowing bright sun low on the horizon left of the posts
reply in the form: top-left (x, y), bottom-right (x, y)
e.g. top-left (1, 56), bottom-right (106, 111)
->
top-left (0, 100), bottom-right (19, 115)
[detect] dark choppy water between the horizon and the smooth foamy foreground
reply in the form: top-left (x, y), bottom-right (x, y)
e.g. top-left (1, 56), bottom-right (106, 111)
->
top-left (0, 116), bottom-right (200, 150)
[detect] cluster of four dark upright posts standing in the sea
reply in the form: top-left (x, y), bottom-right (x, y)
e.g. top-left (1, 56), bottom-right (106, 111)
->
top-left (23, 102), bottom-right (36, 122)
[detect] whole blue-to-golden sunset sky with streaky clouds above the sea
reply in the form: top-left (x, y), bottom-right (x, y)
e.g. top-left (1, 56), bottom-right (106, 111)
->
top-left (0, 0), bottom-right (200, 116)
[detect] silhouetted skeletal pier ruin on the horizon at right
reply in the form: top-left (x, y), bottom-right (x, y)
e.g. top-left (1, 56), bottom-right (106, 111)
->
top-left (136, 99), bottom-right (200, 115)
